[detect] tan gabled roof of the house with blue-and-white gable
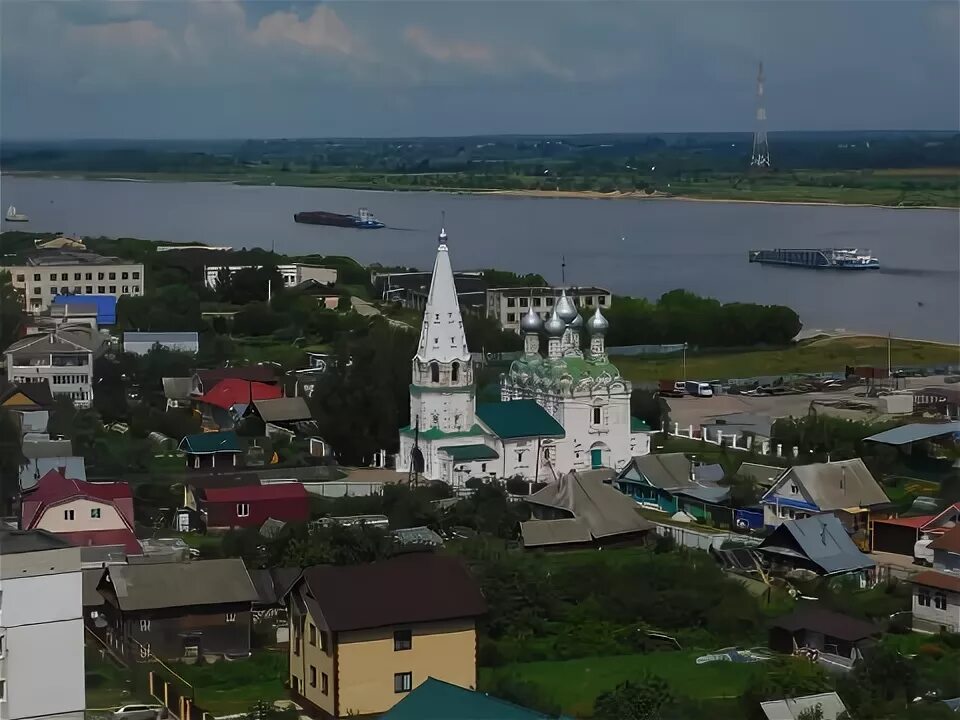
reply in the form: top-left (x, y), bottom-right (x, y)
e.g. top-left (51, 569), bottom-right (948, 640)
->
top-left (764, 458), bottom-right (890, 511)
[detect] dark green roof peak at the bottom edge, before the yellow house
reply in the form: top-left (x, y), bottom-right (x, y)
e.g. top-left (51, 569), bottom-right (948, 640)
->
top-left (380, 678), bottom-right (564, 720)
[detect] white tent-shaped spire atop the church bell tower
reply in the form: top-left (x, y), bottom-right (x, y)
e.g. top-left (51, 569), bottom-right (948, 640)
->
top-left (416, 228), bottom-right (470, 363)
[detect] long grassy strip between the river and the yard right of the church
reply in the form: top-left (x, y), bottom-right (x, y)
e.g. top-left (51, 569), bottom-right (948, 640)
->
top-left (612, 336), bottom-right (960, 382)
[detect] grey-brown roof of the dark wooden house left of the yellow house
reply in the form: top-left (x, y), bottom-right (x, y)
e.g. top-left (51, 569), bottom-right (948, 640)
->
top-left (105, 558), bottom-right (257, 611)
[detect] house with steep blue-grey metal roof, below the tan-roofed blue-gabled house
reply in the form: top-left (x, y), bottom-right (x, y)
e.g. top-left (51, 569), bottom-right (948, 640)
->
top-left (757, 515), bottom-right (876, 578)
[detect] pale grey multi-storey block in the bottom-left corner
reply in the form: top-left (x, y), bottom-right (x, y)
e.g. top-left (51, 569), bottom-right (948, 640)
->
top-left (0, 530), bottom-right (86, 720)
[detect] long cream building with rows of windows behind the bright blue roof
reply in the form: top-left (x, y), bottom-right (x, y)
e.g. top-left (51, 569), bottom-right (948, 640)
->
top-left (3, 248), bottom-right (144, 313)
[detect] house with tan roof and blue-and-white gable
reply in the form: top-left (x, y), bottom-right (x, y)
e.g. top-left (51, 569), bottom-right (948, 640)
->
top-left (760, 458), bottom-right (890, 548)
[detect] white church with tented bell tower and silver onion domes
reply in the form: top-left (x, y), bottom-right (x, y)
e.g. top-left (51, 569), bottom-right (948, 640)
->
top-left (397, 231), bottom-right (651, 488)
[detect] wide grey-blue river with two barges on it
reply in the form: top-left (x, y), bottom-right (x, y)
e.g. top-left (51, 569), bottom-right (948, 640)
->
top-left (0, 176), bottom-right (960, 342)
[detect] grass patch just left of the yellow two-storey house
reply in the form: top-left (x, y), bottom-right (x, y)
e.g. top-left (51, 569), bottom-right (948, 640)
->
top-left (174, 650), bottom-right (288, 715)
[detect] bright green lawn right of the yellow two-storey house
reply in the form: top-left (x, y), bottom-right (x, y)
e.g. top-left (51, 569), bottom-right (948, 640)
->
top-left (480, 651), bottom-right (762, 717)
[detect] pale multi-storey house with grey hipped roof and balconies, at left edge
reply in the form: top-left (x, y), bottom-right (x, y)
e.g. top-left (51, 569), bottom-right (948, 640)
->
top-left (5, 326), bottom-right (104, 407)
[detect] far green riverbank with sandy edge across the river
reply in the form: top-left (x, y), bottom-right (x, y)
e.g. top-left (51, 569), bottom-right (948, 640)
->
top-left (4, 169), bottom-right (960, 210)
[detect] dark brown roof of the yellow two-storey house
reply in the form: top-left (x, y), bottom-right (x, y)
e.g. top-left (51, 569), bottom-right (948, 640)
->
top-left (303, 552), bottom-right (487, 631)
